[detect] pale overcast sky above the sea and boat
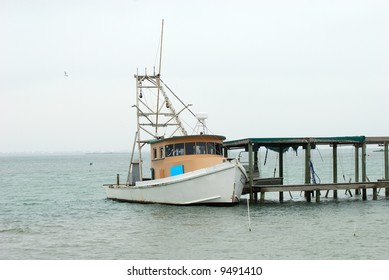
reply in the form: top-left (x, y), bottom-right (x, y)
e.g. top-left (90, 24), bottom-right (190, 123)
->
top-left (0, 0), bottom-right (389, 153)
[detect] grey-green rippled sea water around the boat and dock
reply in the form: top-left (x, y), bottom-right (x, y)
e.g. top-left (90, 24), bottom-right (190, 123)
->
top-left (0, 148), bottom-right (389, 260)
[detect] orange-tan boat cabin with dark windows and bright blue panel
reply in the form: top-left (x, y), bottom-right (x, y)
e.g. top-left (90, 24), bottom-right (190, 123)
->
top-left (149, 134), bottom-right (225, 179)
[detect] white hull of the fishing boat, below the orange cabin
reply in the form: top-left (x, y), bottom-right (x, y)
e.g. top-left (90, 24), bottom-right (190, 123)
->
top-left (105, 160), bottom-right (247, 205)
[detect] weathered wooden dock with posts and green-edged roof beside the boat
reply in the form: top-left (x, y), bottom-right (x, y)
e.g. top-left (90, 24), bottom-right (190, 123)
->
top-left (224, 136), bottom-right (389, 203)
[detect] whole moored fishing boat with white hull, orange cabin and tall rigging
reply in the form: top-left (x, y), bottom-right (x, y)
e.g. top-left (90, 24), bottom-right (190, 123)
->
top-left (104, 21), bottom-right (248, 205)
